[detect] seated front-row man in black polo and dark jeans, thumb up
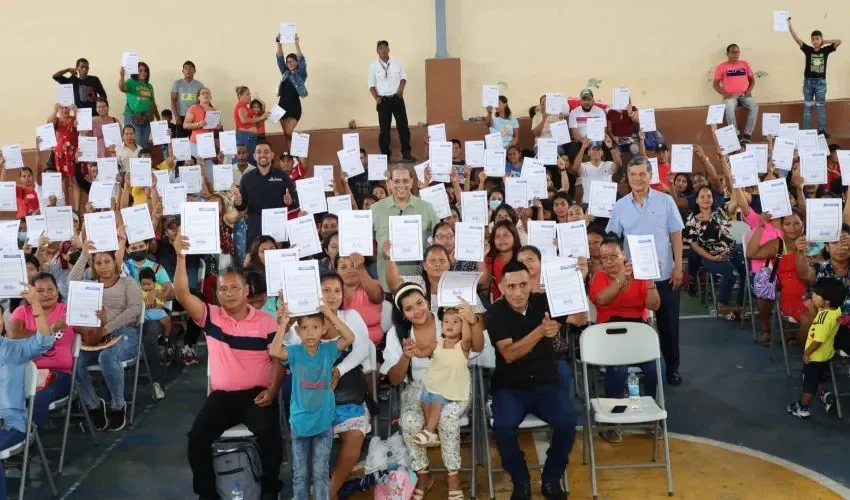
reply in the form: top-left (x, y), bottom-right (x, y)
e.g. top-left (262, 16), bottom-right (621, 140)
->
top-left (486, 260), bottom-right (575, 500)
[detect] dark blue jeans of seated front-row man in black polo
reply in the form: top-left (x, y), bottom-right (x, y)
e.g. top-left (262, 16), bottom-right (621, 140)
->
top-left (492, 384), bottom-right (576, 487)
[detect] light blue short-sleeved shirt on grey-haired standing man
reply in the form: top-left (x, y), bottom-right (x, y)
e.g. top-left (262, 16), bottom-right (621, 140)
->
top-left (605, 189), bottom-right (685, 281)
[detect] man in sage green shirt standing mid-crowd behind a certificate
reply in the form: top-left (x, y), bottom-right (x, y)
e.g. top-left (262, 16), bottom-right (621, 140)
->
top-left (372, 165), bottom-right (440, 292)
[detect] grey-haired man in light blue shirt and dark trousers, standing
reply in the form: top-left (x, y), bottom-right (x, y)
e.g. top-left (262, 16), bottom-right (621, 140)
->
top-left (605, 158), bottom-right (684, 385)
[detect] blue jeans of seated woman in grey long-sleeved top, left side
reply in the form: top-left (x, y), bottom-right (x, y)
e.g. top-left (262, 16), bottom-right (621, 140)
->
top-left (77, 325), bottom-right (139, 410)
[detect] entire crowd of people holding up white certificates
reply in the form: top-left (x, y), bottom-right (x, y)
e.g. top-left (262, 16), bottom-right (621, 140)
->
top-left (0, 17), bottom-right (850, 500)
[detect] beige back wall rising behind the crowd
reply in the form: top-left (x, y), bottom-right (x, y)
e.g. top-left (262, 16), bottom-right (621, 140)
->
top-left (0, 0), bottom-right (850, 147)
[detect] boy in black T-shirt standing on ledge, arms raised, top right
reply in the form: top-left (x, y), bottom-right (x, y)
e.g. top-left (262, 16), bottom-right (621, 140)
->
top-left (788, 17), bottom-right (841, 139)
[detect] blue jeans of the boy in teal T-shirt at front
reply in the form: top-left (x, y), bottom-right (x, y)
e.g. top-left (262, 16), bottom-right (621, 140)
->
top-left (291, 428), bottom-right (334, 500)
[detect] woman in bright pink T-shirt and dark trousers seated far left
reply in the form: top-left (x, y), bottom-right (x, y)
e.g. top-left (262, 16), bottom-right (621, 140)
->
top-left (9, 273), bottom-right (74, 429)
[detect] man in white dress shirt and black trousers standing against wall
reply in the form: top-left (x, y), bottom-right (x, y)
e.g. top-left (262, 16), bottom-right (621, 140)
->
top-left (369, 40), bottom-right (416, 162)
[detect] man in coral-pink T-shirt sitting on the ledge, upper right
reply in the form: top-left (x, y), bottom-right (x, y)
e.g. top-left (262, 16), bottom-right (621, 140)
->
top-left (713, 43), bottom-right (759, 143)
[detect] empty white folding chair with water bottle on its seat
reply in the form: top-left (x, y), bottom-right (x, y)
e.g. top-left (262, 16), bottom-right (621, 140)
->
top-left (581, 323), bottom-right (673, 500)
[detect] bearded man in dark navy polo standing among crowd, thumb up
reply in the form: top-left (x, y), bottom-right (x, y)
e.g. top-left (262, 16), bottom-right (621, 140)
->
top-left (233, 140), bottom-right (298, 247)
